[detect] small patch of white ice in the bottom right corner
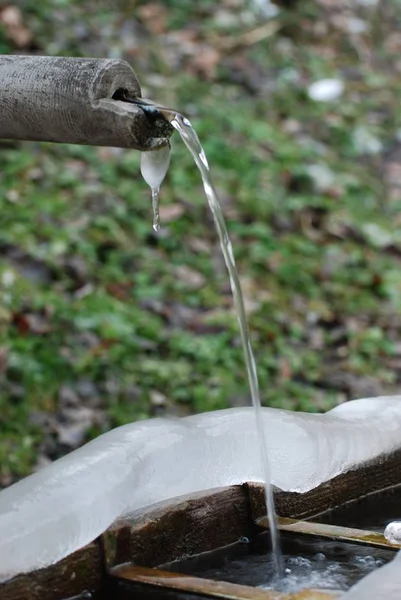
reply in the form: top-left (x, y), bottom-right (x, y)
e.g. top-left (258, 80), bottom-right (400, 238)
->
top-left (341, 552), bottom-right (401, 600)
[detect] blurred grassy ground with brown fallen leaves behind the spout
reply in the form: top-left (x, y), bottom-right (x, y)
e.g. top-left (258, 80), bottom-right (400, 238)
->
top-left (0, 0), bottom-right (401, 486)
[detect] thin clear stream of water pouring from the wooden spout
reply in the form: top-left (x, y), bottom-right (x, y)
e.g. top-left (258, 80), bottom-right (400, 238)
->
top-left (171, 113), bottom-right (283, 577)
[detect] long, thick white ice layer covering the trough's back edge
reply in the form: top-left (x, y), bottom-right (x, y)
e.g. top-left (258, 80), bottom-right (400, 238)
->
top-left (0, 396), bottom-right (401, 580)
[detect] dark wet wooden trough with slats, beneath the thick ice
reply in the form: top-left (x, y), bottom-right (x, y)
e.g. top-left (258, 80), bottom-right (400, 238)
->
top-left (0, 450), bottom-right (401, 600)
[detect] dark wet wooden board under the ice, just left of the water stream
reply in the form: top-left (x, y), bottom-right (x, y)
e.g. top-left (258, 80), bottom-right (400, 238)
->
top-left (103, 486), bottom-right (257, 567)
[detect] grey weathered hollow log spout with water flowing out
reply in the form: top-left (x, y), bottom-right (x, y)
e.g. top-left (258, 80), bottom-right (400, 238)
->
top-left (0, 56), bottom-right (173, 151)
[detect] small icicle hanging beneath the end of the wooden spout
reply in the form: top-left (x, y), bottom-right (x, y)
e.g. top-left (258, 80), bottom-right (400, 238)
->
top-left (141, 144), bottom-right (170, 231)
